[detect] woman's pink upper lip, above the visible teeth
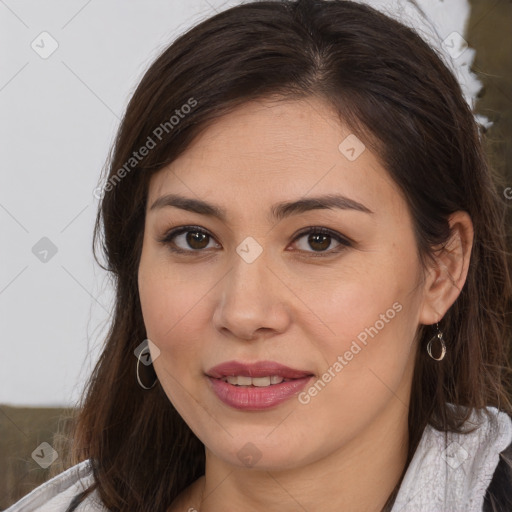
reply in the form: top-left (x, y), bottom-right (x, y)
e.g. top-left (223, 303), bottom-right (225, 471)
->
top-left (206, 361), bottom-right (313, 379)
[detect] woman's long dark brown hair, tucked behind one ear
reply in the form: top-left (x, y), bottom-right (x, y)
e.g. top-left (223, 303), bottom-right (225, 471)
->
top-left (58, 0), bottom-right (512, 512)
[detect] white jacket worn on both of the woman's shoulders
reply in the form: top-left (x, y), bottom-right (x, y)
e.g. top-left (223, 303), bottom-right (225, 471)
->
top-left (5, 407), bottom-right (512, 512)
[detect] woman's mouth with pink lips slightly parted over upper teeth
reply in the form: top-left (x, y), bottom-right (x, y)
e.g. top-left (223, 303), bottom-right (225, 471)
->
top-left (206, 361), bottom-right (314, 410)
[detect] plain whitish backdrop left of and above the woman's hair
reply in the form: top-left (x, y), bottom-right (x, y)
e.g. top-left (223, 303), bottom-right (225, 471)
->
top-left (0, 0), bottom-right (472, 406)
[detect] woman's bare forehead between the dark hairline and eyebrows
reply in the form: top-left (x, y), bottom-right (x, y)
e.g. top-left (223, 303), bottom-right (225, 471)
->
top-left (148, 98), bottom-right (403, 220)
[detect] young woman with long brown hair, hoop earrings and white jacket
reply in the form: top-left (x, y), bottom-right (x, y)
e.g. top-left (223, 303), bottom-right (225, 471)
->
top-left (10, 0), bottom-right (512, 512)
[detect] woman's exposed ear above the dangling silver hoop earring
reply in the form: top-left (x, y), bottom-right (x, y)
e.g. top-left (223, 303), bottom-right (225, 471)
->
top-left (419, 211), bottom-right (474, 325)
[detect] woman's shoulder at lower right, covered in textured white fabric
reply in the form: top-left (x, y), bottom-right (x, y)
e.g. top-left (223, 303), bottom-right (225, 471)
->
top-left (393, 407), bottom-right (512, 512)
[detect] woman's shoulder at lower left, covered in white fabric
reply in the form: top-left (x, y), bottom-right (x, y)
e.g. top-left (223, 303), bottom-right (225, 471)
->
top-left (5, 460), bottom-right (108, 512)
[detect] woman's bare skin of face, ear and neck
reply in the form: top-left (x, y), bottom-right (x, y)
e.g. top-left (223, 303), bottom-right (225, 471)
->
top-left (138, 98), bottom-right (473, 512)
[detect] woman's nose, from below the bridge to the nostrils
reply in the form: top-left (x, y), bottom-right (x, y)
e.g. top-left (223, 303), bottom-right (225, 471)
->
top-left (213, 247), bottom-right (291, 341)
